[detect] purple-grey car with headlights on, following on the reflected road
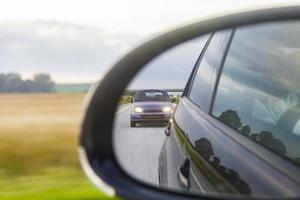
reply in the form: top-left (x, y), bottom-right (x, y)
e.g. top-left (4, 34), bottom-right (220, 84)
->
top-left (130, 90), bottom-right (172, 127)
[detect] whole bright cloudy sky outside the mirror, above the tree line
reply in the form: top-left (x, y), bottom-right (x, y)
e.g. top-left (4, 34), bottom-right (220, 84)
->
top-left (0, 0), bottom-right (300, 83)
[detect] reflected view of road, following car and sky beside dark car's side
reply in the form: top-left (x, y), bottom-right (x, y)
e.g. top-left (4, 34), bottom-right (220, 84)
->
top-left (114, 33), bottom-right (209, 183)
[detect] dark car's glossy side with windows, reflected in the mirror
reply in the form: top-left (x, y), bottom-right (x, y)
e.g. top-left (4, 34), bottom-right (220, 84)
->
top-left (158, 23), bottom-right (300, 197)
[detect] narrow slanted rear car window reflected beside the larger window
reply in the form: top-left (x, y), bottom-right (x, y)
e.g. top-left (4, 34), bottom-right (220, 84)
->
top-left (189, 30), bottom-right (231, 112)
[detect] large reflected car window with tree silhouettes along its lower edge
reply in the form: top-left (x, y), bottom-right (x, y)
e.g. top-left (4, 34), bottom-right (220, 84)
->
top-left (212, 22), bottom-right (300, 164)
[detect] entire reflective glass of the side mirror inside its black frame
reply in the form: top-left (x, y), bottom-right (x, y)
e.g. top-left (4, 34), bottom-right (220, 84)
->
top-left (113, 21), bottom-right (300, 197)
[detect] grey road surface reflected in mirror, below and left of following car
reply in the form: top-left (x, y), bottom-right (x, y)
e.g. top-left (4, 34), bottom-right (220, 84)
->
top-left (114, 105), bottom-right (165, 185)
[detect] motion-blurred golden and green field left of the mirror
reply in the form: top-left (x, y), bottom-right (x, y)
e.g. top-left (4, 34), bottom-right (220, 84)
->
top-left (0, 94), bottom-right (112, 200)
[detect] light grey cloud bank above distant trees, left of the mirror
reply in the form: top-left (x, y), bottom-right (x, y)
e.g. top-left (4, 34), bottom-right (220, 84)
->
top-left (0, 21), bottom-right (141, 82)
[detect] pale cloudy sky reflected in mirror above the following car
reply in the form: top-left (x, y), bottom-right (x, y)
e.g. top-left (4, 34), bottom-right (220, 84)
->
top-left (129, 35), bottom-right (208, 89)
